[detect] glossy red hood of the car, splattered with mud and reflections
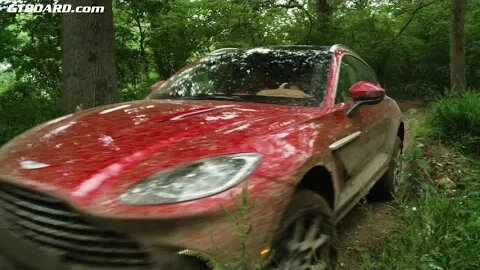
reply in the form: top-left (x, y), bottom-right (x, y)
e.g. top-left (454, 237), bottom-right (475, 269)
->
top-left (0, 100), bottom-right (318, 207)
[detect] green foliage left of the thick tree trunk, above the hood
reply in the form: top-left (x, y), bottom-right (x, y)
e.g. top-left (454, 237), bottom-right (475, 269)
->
top-left (0, 4), bottom-right (61, 145)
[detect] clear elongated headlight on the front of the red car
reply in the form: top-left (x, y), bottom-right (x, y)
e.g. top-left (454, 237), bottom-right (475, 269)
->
top-left (120, 153), bottom-right (260, 205)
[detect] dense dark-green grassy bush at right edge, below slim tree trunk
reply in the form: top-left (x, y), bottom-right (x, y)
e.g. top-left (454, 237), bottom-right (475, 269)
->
top-left (428, 90), bottom-right (480, 153)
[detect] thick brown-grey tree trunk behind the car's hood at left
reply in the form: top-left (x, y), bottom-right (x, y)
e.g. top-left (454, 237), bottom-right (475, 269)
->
top-left (61, 0), bottom-right (117, 113)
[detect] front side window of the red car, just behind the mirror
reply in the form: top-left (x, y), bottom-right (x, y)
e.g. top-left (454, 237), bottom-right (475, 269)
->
top-left (335, 55), bottom-right (378, 103)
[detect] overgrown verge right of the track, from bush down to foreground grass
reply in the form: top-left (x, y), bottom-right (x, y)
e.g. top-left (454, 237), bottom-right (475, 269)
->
top-left (363, 98), bottom-right (480, 270)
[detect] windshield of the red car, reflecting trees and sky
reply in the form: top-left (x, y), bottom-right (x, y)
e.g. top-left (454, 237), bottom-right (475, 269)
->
top-left (153, 48), bottom-right (331, 106)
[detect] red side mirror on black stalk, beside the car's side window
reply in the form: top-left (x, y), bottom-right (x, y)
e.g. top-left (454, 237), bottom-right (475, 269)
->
top-left (347, 81), bottom-right (385, 117)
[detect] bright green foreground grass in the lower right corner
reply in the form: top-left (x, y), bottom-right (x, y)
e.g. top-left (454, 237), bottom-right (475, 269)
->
top-left (365, 158), bottom-right (480, 269)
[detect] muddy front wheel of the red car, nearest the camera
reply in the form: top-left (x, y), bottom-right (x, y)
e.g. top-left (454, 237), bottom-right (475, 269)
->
top-left (267, 189), bottom-right (337, 270)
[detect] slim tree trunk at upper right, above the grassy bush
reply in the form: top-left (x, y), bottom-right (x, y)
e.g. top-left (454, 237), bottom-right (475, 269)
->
top-left (450, 0), bottom-right (467, 91)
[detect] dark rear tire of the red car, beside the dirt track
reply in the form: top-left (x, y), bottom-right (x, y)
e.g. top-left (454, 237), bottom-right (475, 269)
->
top-left (367, 137), bottom-right (402, 202)
